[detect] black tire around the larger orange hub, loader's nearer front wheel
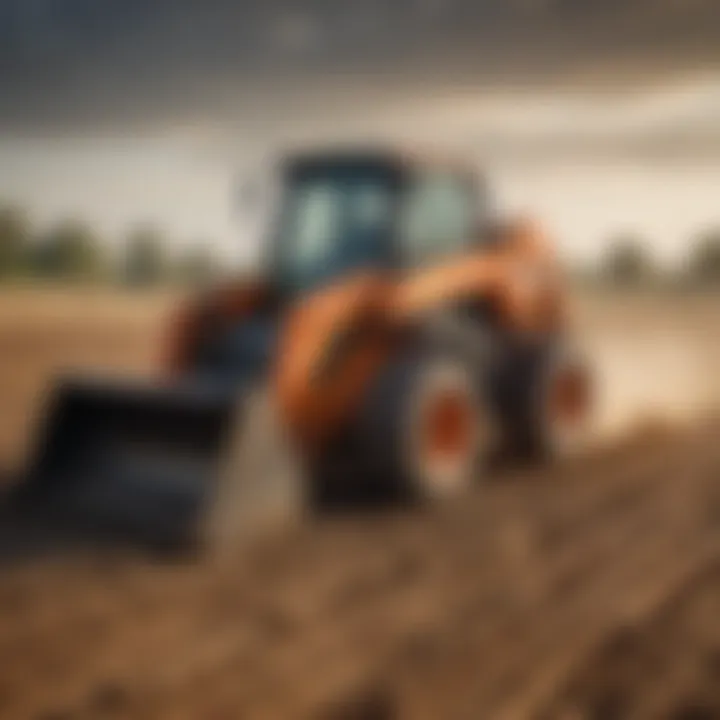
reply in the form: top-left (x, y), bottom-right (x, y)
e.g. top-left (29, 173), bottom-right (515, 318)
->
top-left (357, 351), bottom-right (486, 502)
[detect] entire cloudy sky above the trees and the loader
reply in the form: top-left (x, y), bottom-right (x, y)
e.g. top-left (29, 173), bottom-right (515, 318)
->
top-left (0, 0), bottom-right (720, 263)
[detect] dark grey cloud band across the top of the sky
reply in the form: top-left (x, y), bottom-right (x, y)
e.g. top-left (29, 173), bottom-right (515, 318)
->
top-left (0, 0), bottom-right (720, 134)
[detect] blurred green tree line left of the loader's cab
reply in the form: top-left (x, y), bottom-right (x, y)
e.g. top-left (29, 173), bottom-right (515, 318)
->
top-left (0, 205), bottom-right (218, 287)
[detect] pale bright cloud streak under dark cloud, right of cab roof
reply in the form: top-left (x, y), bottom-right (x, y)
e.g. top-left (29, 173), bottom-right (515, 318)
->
top-left (398, 74), bottom-right (720, 163)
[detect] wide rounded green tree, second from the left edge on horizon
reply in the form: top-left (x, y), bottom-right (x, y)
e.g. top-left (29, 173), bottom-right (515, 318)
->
top-left (30, 220), bottom-right (107, 281)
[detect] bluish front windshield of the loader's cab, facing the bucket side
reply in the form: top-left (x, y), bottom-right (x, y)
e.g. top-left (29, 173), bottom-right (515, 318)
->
top-left (275, 168), bottom-right (394, 292)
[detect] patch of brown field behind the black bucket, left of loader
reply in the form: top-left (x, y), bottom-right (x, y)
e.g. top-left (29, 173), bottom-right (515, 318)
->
top-left (0, 288), bottom-right (174, 467)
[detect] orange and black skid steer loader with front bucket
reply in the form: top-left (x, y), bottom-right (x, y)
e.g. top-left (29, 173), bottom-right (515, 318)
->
top-left (9, 149), bottom-right (590, 543)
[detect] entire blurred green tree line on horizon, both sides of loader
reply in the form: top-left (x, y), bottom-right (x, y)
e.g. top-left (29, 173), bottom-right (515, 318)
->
top-left (0, 200), bottom-right (720, 288)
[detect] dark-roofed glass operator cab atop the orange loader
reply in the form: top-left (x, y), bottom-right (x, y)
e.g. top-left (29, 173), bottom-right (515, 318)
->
top-left (258, 151), bottom-right (487, 296)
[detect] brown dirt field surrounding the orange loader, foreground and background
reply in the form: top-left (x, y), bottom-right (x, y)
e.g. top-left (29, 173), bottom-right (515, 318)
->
top-left (0, 294), bottom-right (720, 720)
